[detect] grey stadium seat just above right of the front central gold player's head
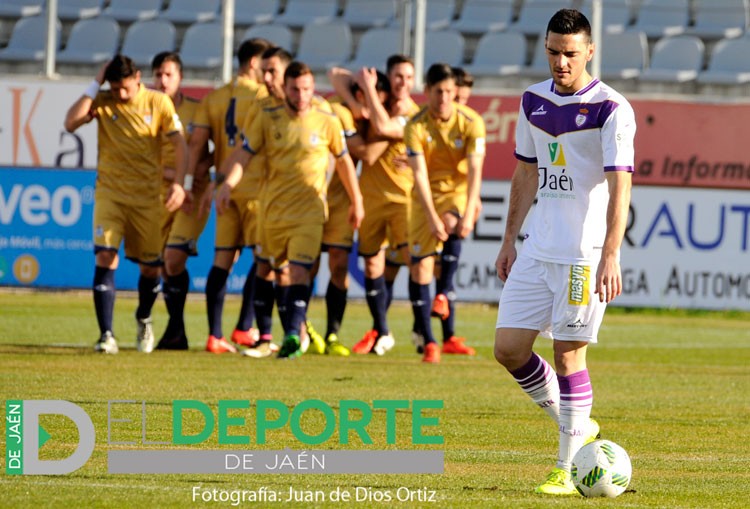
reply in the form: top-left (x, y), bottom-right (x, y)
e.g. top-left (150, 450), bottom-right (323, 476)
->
top-left (296, 21), bottom-right (352, 72)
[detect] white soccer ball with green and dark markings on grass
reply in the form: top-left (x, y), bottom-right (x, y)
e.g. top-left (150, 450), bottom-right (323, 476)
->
top-left (570, 440), bottom-right (632, 498)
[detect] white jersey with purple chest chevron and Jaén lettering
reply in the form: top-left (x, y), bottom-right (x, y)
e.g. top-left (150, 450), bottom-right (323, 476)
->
top-left (515, 79), bottom-right (635, 265)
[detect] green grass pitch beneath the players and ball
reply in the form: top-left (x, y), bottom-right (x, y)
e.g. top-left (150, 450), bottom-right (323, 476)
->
top-left (0, 291), bottom-right (750, 508)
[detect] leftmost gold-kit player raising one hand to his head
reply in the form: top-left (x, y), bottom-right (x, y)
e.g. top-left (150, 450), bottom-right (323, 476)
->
top-left (65, 55), bottom-right (187, 354)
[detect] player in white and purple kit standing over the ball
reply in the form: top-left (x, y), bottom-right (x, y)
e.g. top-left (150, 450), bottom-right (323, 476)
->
top-left (495, 9), bottom-right (635, 495)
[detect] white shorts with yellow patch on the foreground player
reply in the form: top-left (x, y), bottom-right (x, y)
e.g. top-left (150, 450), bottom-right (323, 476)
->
top-left (496, 254), bottom-right (607, 343)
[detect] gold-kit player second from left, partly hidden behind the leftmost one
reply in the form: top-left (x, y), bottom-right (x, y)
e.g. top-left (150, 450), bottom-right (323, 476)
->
top-left (151, 51), bottom-right (213, 350)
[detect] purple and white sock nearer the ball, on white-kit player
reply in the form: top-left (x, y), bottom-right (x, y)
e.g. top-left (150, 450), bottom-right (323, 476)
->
top-left (557, 369), bottom-right (594, 471)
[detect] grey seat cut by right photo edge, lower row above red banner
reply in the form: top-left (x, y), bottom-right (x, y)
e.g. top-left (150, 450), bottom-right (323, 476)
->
top-left (698, 37), bottom-right (750, 85)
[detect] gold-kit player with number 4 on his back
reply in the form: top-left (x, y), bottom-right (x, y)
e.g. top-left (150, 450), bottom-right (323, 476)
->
top-left (190, 38), bottom-right (271, 353)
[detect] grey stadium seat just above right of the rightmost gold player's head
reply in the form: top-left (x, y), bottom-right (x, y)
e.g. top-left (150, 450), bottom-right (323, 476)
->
top-left (464, 32), bottom-right (526, 77)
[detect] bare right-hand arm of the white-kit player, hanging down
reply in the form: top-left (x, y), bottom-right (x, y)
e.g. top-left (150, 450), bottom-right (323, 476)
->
top-left (596, 171), bottom-right (632, 302)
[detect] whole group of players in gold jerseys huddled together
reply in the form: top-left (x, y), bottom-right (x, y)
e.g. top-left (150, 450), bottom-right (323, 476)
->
top-left (65, 38), bottom-right (485, 363)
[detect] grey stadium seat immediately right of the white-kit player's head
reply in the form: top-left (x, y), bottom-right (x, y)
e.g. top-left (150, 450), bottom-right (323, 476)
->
top-left (600, 32), bottom-right (648, 80)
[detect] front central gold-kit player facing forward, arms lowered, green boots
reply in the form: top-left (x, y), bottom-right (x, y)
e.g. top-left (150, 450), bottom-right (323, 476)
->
top-left (216, 62), bottom-right (364, 358)
